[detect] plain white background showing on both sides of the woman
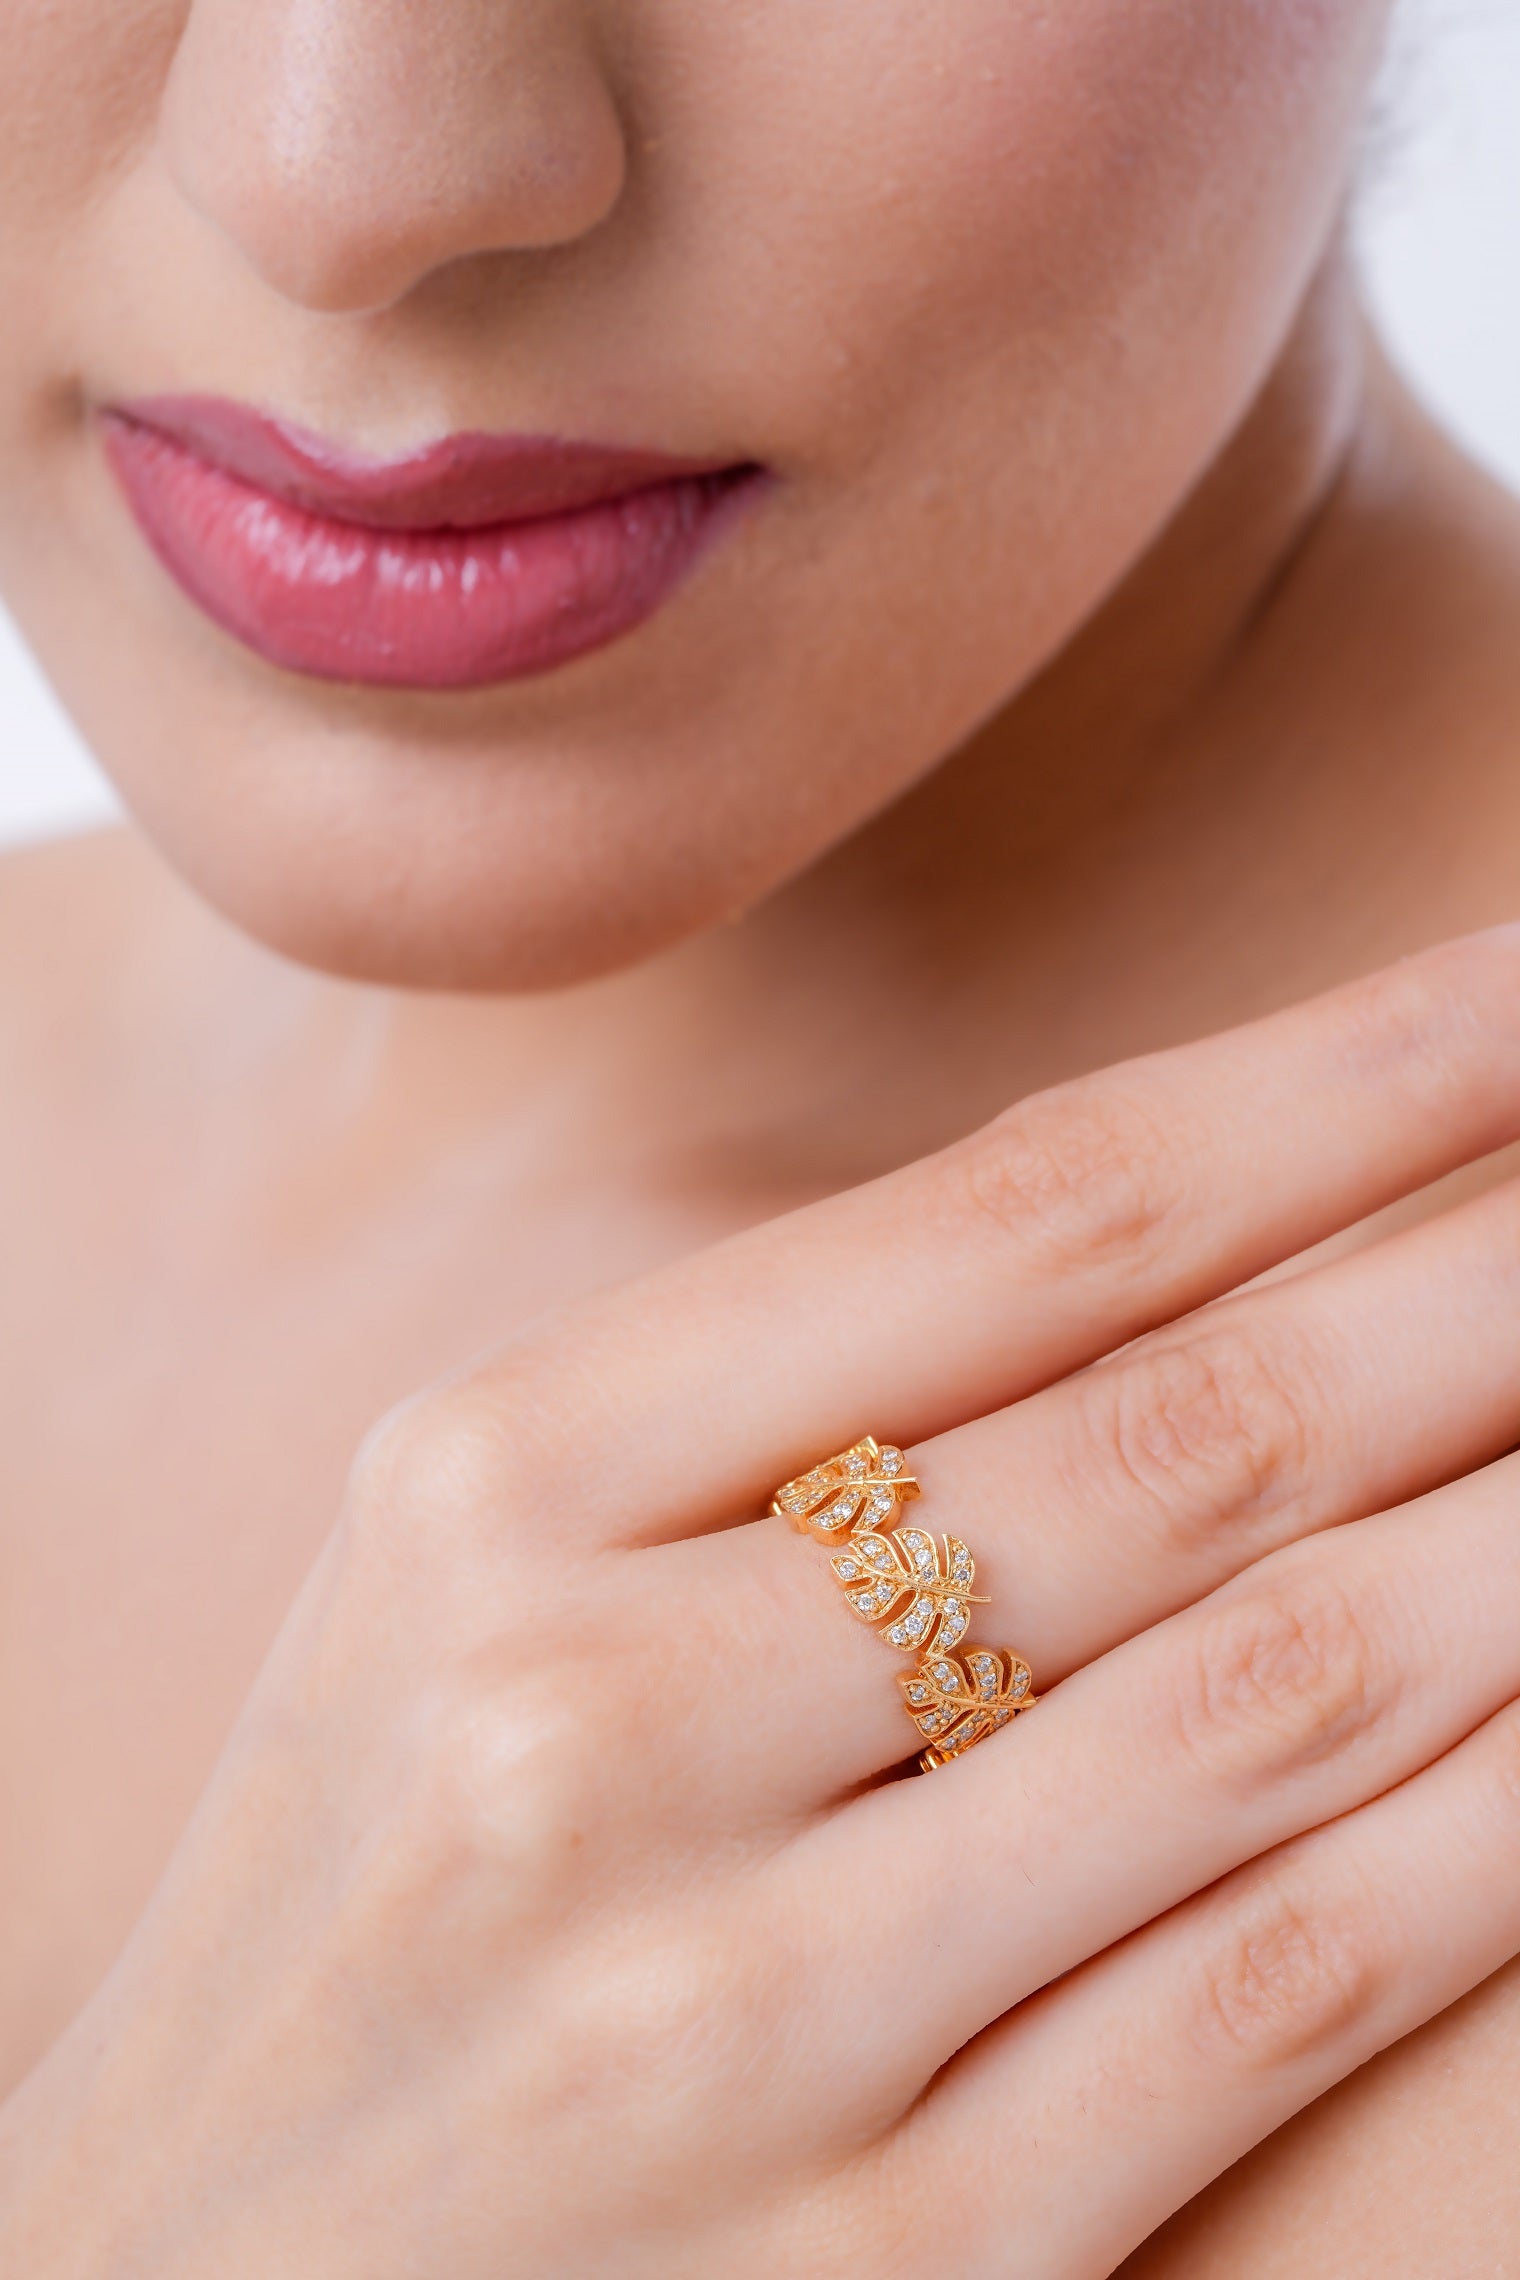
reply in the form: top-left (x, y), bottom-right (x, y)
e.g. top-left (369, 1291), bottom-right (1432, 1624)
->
top-left (0, 0), bottom-right (1520, 841)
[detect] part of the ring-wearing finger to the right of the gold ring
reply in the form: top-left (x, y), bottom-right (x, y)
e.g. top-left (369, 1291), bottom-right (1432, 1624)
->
top-left (912, 1158), bottom-right (1520, 1683)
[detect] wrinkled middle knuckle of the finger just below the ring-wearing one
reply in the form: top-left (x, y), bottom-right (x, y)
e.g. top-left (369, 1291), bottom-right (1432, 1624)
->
top-left (1171, 1562), bottom-right (1390, 1790)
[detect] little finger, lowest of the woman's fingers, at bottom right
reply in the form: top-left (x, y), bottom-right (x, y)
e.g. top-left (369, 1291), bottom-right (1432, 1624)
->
top-left (868, 1705), bottom-right (1520, 2280)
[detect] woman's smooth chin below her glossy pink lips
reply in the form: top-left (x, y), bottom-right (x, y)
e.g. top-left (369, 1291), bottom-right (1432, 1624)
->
top-left (65, 588), bottom-right (902, 992)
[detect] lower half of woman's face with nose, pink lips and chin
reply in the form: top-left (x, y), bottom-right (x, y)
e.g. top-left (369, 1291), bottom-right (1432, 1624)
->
top-left (0, 0), bottom-right (1386, 987)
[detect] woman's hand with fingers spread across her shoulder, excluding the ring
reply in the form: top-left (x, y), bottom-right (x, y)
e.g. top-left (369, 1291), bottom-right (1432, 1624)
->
top-left (0, 930), bottom-right (1520, 2280)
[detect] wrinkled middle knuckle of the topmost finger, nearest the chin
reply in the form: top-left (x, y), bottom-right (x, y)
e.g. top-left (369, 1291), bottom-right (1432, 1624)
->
top-left (953, 1078), bottom-right (1187, 1265)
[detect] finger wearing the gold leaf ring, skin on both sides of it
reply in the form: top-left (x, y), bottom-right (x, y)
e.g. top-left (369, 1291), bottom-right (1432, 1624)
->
top-left (633, 1158), bottom-right (1520, 1813)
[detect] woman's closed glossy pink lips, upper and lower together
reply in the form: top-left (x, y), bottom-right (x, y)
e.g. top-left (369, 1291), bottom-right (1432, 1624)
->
top-left (103, 397), bottom-right (761, 689)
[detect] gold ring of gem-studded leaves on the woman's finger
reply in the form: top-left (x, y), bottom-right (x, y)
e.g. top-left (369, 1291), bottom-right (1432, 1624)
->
top-left (770, 1436), bottom-right (1039, 1774)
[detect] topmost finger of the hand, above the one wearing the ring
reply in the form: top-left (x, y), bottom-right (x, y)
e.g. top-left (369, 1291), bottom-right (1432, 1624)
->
top-left (455, 928), bottom-right (1520, 1541)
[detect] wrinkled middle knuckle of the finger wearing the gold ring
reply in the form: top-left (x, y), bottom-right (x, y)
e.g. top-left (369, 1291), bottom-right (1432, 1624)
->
top-left (1085, 1322), bottom-right (1313, 1548)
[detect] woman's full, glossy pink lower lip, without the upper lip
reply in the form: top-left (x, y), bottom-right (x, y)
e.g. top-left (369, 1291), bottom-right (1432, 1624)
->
top-left (105, 417), bottom-right (761, 689)
